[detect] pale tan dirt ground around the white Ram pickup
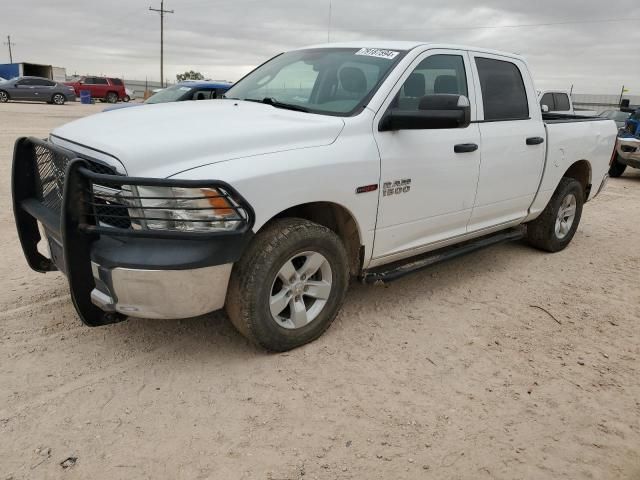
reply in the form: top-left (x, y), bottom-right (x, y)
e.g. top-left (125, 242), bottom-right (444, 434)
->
top-left (0, 99), bottom-right (640, 480)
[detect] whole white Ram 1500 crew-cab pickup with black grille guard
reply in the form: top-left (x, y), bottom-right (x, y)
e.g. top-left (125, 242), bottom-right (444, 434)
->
top-left (12, 42), bottom-right (616, 351)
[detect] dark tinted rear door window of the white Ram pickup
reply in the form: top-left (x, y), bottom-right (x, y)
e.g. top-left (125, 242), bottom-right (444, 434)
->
top-left (476, 57), bottom-right (529, 121)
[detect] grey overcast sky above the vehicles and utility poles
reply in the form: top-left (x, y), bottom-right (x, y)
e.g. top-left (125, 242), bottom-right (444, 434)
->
top-left (0, 0), bottom-right (640, 95)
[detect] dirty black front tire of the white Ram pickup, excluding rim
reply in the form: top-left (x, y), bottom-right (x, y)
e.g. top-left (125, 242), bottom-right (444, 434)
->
top-left (225, 218), bottom-right (349, 352)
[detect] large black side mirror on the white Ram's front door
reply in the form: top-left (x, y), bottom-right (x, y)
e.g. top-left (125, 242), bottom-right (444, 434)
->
top-left (378, 94), bottom-right (471, 132)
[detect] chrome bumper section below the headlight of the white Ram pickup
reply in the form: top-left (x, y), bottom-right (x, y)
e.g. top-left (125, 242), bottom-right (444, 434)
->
top-left (91, 262), bottom-right (233, 319)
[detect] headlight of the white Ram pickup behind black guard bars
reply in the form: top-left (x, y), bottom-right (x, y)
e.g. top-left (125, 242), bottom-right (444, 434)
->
top-left (124, 185), bottom-right (246, 232)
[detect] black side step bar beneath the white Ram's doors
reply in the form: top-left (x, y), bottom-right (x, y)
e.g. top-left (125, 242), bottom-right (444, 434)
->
top-left (362, 227), bottom-right (524, 283)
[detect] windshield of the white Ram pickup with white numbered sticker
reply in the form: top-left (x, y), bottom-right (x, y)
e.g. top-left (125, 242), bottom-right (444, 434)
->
top-left (225, 48), bottom-right (404, 116)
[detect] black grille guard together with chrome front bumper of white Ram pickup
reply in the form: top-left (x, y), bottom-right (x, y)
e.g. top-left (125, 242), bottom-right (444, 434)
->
top-left (11, 138), bottom-right (255, 327)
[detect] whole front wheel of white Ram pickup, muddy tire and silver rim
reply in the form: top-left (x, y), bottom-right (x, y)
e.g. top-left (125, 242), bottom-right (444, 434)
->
top-left (225, 219), bottom-right (349, 352)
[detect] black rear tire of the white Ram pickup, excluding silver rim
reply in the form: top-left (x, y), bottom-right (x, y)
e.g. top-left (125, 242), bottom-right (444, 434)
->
top-left (527, 177), bottom-right (584, 252)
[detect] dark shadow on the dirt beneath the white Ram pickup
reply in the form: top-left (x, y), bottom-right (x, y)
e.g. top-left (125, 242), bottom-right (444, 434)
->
top-left (92, 242), bottom-right (544, 357)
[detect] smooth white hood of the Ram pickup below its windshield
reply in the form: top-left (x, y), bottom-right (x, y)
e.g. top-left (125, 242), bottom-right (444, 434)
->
top-left (51, 100), bottom-right (344, 178)
